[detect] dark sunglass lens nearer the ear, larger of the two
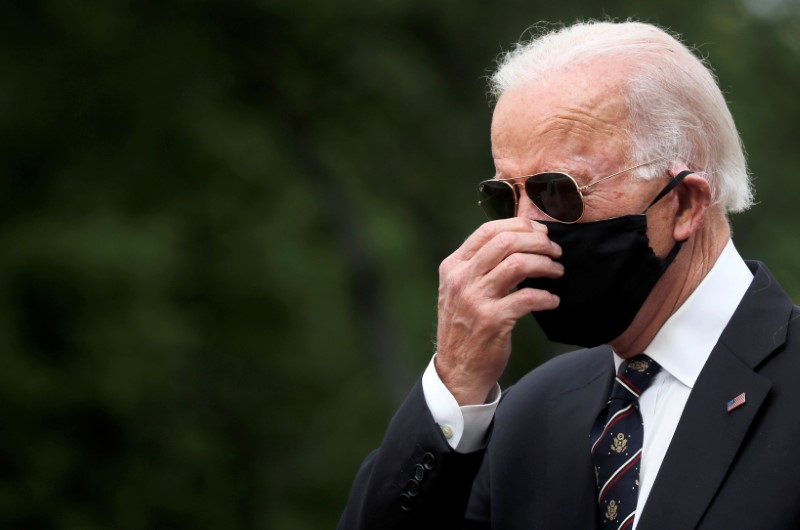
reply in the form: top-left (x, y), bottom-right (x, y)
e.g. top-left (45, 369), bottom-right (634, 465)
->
top-left (525, 173), bottom-right (583, 223)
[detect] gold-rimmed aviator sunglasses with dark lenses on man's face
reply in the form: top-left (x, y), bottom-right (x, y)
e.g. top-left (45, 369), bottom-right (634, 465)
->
top-left (478, 157), bottom-right (666, 223)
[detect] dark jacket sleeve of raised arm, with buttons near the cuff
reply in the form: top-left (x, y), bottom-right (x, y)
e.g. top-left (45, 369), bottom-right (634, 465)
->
top-left (338, 382), bottom-right (489, 530)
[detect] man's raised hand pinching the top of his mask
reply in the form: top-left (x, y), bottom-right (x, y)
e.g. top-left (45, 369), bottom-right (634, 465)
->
top-left (436, 217), bottom-right (564, 406)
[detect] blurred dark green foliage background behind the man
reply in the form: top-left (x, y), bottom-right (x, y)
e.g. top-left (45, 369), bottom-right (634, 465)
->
top-left (0, 0), bottom-right (800, 530)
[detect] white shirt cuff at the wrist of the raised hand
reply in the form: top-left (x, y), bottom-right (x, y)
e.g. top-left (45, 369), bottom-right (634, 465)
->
top-left (422, 355), bottom-right (501, 453)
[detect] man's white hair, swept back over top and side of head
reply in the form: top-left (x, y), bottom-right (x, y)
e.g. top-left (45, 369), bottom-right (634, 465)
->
top-left (490, 21), bottom-right (753, 212)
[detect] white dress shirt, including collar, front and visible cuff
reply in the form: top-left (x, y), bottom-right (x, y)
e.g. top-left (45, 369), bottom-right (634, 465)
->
top-left (422, 241), bottom-right (753, 528)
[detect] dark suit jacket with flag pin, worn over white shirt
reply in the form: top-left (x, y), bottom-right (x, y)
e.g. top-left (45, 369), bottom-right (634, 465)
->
top-left (339, 263), bottom-right (800, 530)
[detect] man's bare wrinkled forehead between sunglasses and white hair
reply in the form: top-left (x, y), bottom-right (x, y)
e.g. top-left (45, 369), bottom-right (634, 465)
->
top-left (491, 60), bottom-right (630, 176)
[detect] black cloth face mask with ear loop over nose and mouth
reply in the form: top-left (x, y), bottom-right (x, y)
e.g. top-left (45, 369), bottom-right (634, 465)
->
top-left (519, 171), bottom-right (691, 348)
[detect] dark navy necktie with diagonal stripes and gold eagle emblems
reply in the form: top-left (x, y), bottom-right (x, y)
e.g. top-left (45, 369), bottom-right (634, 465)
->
top-left (591, 354), bottom-right (661, 530)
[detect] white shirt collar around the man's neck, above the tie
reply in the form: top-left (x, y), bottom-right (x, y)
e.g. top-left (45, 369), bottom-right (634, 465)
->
top-left (614, 240), bottom-right (753, 388)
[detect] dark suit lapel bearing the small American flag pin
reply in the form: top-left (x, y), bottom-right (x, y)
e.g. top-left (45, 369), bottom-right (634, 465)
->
top-left (638, 264), bottom-right (792, 530)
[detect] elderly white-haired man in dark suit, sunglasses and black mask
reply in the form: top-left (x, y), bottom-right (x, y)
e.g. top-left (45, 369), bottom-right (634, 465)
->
top-left (340, 22), bottom-right (800, 530)
